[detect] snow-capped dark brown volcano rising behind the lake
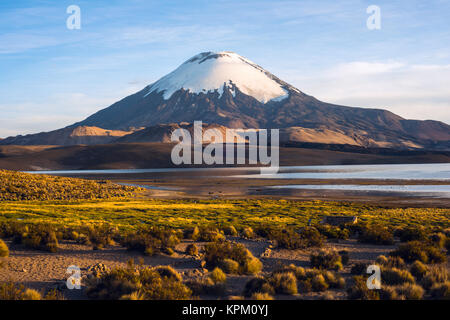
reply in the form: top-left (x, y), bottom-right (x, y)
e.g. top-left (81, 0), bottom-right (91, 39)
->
top-left (0, 51), bottom-right (450, 149)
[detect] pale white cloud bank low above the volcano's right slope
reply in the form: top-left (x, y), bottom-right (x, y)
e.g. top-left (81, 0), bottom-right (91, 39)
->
top-left (288, 61), bottom-right (450, 123)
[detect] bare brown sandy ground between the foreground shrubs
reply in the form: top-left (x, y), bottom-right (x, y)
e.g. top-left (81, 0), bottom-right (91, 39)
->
top-left (0, 237), bottom-right (400, 299)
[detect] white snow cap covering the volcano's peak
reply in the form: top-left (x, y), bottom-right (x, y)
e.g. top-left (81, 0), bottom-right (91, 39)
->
top-left (145, 51), bottom-right (289, 103)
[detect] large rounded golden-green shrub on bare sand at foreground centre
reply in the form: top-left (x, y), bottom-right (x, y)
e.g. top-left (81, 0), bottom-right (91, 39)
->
top-left (205, 241), bottom-right (262, 274)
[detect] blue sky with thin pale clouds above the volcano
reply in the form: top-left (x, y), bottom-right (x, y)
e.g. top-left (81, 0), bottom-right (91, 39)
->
top-left (0, 0), bottom-right (450, 138)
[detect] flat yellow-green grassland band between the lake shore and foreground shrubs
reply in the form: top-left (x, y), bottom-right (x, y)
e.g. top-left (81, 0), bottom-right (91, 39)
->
top-left (0, 199), bottom-right (450, 230)
